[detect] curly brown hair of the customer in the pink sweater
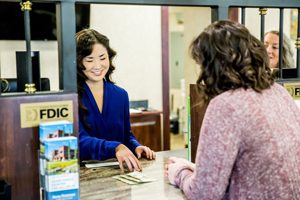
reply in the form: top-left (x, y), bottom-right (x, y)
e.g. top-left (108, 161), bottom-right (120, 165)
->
top-left (190, 20), bottom-right (274, 102)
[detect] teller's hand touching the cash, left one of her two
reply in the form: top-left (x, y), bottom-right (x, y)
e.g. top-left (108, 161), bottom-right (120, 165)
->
top-left (116, 144), bottom-right (142, 172)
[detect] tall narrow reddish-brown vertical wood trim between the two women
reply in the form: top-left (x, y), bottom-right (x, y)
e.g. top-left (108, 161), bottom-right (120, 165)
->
top-left (161, 6), bottom-right (170, 150)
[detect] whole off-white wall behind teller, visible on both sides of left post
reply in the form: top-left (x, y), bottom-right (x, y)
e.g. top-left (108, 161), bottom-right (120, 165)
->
top-left (0, 4), bottom-right (162, 110)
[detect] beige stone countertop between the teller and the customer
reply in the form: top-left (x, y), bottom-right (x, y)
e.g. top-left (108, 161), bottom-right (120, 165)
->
top-left (80, 149), bottom-right (187, 200)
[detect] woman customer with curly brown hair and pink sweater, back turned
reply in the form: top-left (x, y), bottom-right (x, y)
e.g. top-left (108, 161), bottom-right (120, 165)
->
top-left (165, 21), bottom-right (300, 200)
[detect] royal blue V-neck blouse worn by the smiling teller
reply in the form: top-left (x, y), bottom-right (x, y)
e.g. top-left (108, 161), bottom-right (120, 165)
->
top-left (79, 81), bottom-right (140, 160)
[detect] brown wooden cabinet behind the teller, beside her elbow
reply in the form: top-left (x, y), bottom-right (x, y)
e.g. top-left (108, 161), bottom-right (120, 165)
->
top-left (130, 112), bottom-right (162, 151)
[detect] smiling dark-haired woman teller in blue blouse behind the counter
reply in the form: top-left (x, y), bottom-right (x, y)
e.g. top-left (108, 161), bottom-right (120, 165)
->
top-left (76, 29), bottom-right (155, 171)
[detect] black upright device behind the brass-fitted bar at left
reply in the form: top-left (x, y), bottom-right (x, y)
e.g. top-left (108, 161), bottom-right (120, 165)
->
top-left (16, 51), bottom-right (41, 92)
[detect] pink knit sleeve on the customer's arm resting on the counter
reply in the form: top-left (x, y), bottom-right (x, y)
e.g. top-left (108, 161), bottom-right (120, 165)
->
top-left (175, 97), bottom-right (241, 200)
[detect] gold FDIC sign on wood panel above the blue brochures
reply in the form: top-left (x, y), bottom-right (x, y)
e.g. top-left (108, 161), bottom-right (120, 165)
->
top-left (20, 101), bottom-right (73, 128)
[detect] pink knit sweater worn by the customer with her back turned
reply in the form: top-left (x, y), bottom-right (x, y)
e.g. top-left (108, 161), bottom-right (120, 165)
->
top-left (175, 84), bottom-right (300, 200)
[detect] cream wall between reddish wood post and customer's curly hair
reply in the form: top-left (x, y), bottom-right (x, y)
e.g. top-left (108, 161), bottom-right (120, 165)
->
top-left (169, 7), bottom-right (211, 132)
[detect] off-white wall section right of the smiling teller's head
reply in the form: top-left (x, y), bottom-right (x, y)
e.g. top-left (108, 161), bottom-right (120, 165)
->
top-left (90, 4), bottom-right (162, 110)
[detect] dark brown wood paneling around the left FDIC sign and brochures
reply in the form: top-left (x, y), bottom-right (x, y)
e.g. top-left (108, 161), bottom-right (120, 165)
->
top-left (0, 94), bottom-right (78, 200)
